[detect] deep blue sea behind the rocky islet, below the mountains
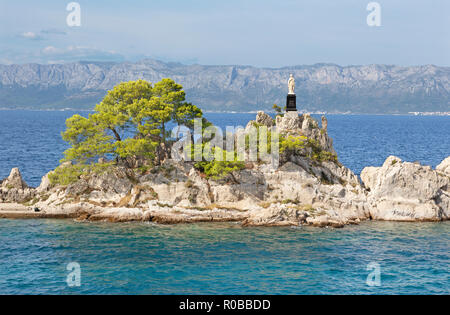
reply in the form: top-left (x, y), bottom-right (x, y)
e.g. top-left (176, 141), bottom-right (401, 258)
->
top-left (0, 111), bottom-right (450, 186)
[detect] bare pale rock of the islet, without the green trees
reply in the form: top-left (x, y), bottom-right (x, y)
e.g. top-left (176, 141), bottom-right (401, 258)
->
top-left (0, 112), bottom-right (450, 228)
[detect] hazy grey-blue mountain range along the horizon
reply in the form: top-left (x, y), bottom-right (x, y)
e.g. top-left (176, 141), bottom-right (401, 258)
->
top-left (0, 60), bottom-right (450, 114)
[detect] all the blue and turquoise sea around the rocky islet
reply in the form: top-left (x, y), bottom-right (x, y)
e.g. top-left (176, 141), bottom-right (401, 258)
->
top-left (0, 111), bottom-right (450, 294)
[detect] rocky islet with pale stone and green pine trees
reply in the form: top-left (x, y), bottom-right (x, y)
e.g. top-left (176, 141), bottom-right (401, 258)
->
top-left (0, 80), bottom-right (450, 228)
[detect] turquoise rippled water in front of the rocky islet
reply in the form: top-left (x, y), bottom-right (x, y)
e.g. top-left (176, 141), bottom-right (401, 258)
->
top-left (0, 220), bottom-right (450, 294)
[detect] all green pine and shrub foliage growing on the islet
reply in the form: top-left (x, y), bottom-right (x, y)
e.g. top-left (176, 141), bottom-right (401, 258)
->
top-left (58, 79), bottom-right (337, 186)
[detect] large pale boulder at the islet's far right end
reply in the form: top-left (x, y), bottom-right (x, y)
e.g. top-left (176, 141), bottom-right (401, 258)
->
top-left (361, 156), bottom-right (450, 221)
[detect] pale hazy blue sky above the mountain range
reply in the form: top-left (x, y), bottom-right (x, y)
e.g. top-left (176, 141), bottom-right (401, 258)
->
top-left (0, 0), bottom-right (450, 67)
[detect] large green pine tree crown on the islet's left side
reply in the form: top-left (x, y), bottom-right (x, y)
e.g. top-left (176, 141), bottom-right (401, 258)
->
top-left (62, 79), bottom-right (203, 172)
